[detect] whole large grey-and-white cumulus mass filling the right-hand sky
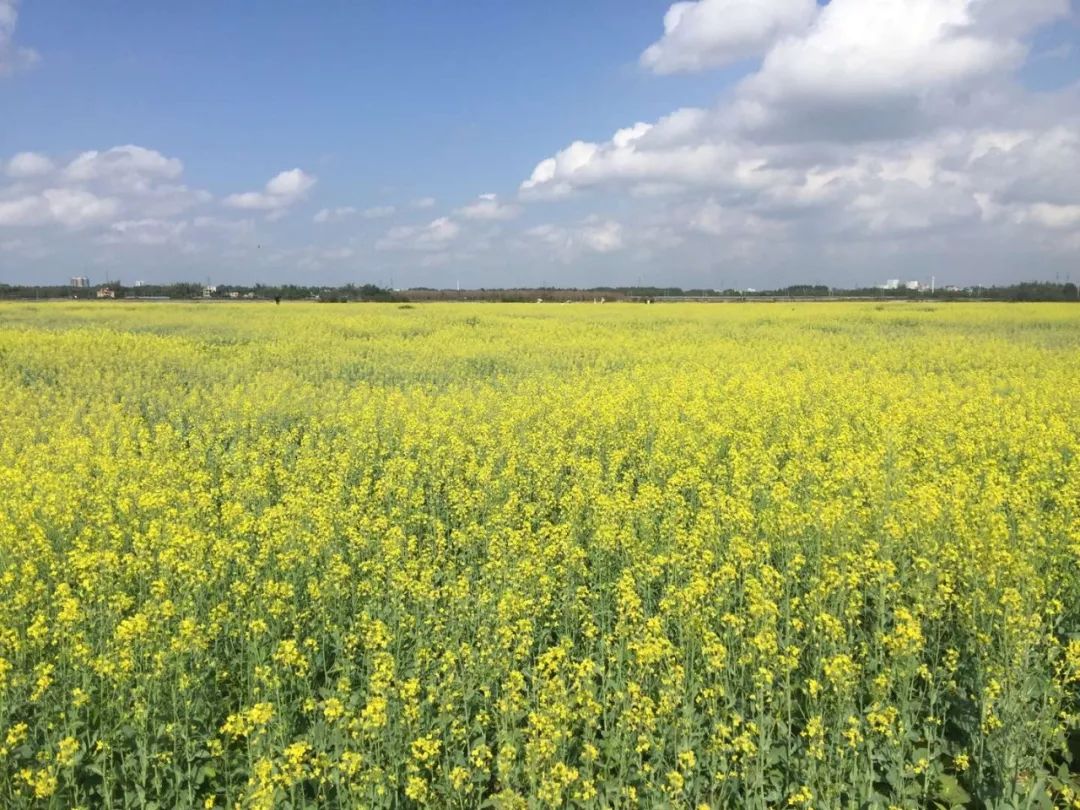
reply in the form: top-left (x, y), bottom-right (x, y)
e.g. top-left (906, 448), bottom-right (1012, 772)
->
top-left (519, 0), bottom-right (1080, 273)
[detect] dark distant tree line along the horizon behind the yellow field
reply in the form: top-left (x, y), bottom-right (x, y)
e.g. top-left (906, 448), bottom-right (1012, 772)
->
top-left (0, 281), bottom-right (1080, 303)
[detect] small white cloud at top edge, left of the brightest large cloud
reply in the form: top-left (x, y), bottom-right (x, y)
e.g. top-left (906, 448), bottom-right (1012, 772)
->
top-left (642, 0), bottom-right (818, 73)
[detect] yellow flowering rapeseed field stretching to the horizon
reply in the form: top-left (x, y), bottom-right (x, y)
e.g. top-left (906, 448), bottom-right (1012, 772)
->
top-left (0, 301), bottom-right (1080, 808)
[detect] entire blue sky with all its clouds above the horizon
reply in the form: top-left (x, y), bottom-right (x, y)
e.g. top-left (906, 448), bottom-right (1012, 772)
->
top-left (0, 0), bottom-right (1080, 287)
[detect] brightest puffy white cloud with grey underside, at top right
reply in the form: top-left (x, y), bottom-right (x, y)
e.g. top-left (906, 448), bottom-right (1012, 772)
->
top-left (734, 0), bottom-right (1067, 140)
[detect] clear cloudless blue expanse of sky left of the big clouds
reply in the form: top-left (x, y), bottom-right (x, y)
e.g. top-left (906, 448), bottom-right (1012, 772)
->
top-left (8, 0), bottom-right (715, 199)
